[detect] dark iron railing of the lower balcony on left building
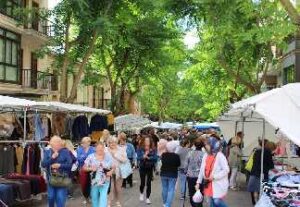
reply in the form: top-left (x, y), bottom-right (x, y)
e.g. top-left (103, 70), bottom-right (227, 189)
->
top-left (21, 69), bottom-right (58, 91)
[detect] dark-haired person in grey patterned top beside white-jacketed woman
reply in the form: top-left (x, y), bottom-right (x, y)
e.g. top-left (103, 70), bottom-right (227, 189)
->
top-left (185, 138), bottom-right (205, 207)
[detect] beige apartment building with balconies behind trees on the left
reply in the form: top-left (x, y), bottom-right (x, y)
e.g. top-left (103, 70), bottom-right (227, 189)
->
top-left (0, 0), bottom-right (111, 109)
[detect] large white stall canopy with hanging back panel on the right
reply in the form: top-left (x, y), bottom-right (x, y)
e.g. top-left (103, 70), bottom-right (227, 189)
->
top-left (218, 83), bottom-right (300, 155)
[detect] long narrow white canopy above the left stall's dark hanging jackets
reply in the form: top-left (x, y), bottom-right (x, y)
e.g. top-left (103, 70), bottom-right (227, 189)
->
top-left (33, 101), bottom-right (111, 114)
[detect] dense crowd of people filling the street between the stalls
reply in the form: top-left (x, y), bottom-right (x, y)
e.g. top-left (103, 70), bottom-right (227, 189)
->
top-left (42, 128), bottom-right (273, 207)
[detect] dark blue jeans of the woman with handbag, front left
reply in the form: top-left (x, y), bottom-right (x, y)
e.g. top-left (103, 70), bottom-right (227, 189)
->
top-left (48, 185), bottom-right (68, 207)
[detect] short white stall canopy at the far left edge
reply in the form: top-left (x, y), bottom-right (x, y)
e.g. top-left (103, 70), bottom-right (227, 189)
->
top-left (0, 95), bottom-right (36, 110)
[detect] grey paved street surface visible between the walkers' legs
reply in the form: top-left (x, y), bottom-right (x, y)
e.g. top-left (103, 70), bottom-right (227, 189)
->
top-left (18, 171), bottom-right (251, 207)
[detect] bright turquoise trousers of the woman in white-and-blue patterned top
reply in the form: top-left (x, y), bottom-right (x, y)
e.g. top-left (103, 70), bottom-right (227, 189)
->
top-left (91, 182), bottom-right (110, 207)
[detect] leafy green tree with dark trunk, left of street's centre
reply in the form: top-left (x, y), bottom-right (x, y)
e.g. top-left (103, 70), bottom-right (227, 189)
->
top-left (92, 1), bottom-right (178, 114)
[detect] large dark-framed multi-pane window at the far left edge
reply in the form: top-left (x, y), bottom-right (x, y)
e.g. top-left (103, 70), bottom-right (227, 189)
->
top-left (0, 28), bottom-right (20, 83)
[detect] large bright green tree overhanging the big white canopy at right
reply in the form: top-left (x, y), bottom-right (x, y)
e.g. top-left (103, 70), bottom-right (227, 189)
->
top-left (183, 0), bottom-right (295, 119)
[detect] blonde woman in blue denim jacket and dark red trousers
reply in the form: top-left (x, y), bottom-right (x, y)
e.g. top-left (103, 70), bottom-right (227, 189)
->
top-left (77, 137), bottom-right (95, 204)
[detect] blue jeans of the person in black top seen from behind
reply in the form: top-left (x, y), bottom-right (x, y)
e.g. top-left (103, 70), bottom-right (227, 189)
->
top-left (161, 176), bottom-right (177, 207)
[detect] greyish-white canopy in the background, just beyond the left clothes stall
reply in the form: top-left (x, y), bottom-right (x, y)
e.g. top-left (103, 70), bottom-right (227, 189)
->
top-left (115, 114), bottom-right (151, 131)
